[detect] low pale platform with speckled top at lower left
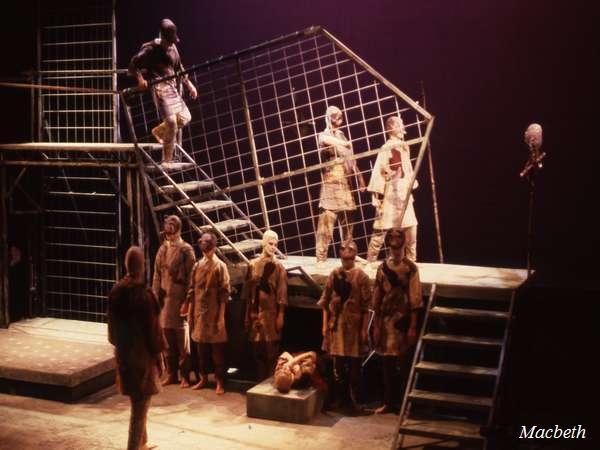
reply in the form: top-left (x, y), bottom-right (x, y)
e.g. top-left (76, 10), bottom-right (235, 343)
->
top-left (0, 318), bottom-right (115, 402)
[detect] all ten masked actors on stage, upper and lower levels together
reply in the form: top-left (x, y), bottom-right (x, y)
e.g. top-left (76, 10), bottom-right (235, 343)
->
top-left (108, 19), bottom-right (422, 449)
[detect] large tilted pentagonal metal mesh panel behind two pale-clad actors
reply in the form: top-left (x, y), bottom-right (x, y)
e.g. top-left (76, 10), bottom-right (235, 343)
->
top-left (123, 29), bottom-right (431, 256)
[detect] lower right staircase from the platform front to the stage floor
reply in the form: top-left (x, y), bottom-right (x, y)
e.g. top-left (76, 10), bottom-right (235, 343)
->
top-left (392, 284), bottom-right (515, 450)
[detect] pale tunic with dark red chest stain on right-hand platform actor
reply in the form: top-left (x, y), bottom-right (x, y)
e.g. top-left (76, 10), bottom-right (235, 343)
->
top-left (367, 139), bottom-right (418, 230)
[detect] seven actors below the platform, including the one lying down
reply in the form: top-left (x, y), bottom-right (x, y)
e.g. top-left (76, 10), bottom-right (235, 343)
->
top-left (108, 221), bottom-right (422, 449)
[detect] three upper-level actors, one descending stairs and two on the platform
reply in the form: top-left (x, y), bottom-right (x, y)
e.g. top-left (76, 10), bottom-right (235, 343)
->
top-left (129, 18), bottom-right (418, 261)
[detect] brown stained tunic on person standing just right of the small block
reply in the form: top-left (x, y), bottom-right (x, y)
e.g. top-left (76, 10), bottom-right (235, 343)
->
top-left (317, 267), bottom-right (371, 357)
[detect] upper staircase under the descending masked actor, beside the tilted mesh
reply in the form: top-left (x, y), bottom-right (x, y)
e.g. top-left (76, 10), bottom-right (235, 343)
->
top-left (131, 145), bottom-right (263, 264)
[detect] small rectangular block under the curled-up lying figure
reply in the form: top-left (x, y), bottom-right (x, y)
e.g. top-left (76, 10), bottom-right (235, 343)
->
top-left (246, 377), bottom-right (323, 423)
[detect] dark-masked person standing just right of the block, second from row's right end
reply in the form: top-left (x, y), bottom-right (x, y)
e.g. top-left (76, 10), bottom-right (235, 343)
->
top-left (318, 242), bottom-right (371, 413)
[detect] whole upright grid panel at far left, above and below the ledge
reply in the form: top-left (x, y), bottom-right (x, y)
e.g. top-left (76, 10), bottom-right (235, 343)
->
top-left (38, 0), bottom-right (122, 321)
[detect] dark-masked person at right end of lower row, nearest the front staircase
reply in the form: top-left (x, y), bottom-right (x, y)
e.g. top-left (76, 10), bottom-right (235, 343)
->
top-left (371, 230), bottom-right (423, 413)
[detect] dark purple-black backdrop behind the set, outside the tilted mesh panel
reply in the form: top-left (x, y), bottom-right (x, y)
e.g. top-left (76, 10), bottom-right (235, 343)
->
top-left (0, 0), bottom-right (600, 276)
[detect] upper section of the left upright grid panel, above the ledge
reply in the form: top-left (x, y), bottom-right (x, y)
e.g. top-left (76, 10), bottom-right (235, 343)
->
top-left (38, 0), bottom-right (117, 142)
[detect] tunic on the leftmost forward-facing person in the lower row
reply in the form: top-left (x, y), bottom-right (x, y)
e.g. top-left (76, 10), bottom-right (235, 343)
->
top-left (152, 238), bottom-right (196, 328)
